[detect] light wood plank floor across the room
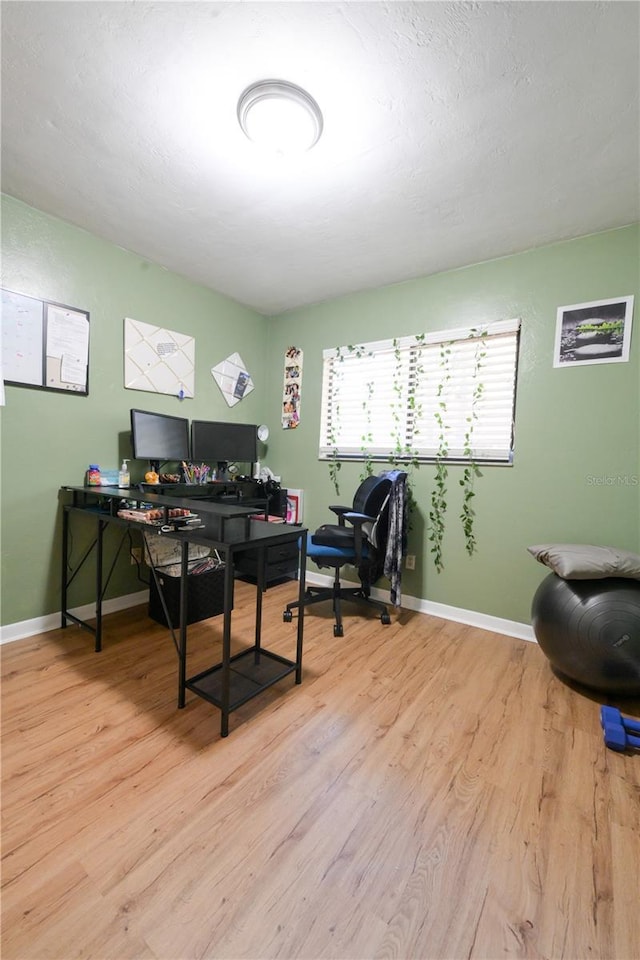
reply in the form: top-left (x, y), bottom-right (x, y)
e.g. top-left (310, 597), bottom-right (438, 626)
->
top-left (2, 584), bottom-right (640, 960)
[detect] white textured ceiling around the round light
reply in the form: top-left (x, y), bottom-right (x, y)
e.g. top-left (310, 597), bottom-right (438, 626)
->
top-left (2, 0), bottom-right (640, 315)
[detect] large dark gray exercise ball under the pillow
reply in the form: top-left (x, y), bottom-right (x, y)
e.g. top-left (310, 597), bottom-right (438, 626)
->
top-left (531, 573), bottom-right (640, 696)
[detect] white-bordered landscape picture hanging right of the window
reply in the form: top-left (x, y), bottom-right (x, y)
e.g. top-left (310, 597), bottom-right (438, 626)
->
top-left (553, 297), bottom-right (633, 367)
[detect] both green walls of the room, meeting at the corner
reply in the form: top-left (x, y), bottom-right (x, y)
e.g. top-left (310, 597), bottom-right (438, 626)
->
top-left (0, 197), bottom-right (640, 624)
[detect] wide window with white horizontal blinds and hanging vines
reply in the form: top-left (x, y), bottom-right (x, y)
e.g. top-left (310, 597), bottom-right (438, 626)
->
top-left (319, 320), bottom-right (520, 463)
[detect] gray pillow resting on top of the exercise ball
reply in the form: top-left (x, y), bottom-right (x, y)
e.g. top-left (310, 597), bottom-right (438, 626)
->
top-left (527, 543), bottom-right (640, 580)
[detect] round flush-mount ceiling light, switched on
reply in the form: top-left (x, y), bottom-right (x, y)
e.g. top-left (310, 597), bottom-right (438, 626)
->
top-left (238, 80), bottom-right (322, 153)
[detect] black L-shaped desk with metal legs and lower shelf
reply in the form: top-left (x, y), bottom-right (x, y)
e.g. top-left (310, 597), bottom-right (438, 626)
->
top-left (62, 486), bottom-right (306, 737)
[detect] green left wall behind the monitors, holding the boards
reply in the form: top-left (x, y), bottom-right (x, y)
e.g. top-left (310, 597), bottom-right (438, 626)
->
top-left (0, 196), bottom-right (268, 625)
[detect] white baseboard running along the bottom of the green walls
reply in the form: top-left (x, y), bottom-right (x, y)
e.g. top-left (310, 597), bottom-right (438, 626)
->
top-left (0, 573), bottom-right (536, 644)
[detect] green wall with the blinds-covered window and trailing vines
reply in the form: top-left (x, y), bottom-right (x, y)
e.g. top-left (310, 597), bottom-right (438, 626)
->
top-left (262, 225), bottom-right (640, 622)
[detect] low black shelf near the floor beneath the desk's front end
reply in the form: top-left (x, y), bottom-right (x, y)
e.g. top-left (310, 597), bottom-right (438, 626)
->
top-left (185, 647), bottom-right (297, 711)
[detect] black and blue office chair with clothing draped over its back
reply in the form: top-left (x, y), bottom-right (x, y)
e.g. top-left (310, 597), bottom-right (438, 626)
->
top-left (282, 470), bottom-right (407, 637)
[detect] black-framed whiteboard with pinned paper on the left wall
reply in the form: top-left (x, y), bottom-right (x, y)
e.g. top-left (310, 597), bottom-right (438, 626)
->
top-left (2, 289), bottom-right (89, 397)
